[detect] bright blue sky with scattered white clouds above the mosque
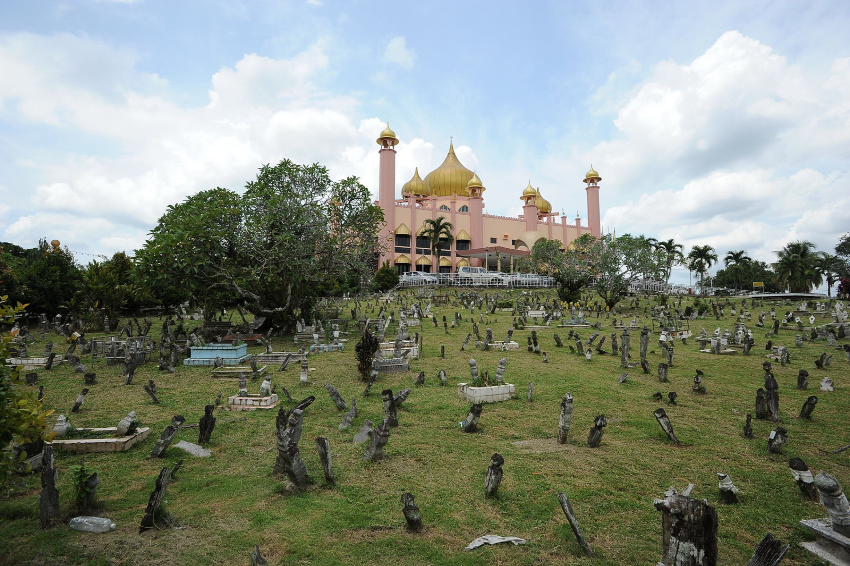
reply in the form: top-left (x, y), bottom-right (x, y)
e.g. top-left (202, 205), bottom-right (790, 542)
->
top-left (0, 0), bottom-right (850, 282)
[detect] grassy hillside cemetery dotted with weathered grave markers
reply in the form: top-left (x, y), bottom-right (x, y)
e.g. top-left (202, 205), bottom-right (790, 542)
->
top-left (0, 288), bottom-right (850, 566)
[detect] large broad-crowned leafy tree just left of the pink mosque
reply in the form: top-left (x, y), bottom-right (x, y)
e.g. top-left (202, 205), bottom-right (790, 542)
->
top-left (136, 160), bottom-right (383, 328)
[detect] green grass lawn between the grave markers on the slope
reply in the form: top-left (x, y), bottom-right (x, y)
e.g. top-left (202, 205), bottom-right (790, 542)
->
top-left (0, 290), bottom-right (850, 565)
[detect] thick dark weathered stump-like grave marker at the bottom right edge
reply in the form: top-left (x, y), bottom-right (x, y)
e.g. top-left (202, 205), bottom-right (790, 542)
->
top-left (653, 492), bottom-right (717, 566)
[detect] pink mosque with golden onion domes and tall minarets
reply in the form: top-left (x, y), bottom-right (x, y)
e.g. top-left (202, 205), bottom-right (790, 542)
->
top-left (377, 125), bottom-right (602, 273)
